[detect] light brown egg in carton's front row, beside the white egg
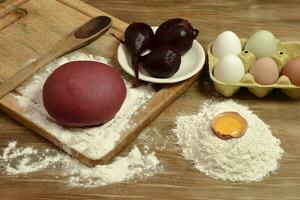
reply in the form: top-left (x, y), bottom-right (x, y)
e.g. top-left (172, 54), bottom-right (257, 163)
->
top-left (249, 57), bottom-right (279, 85)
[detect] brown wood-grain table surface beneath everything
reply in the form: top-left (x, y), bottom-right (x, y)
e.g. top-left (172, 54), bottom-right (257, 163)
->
top-left (0, 0), bottom-right (300, 200)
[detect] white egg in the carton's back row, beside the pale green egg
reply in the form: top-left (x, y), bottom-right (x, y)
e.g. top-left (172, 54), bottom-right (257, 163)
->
top-left (212, 31), bottom-right (242, 58)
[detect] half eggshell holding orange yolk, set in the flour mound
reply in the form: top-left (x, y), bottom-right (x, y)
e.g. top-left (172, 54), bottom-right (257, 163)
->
top-left (212, 112), bottom-right (247, 139)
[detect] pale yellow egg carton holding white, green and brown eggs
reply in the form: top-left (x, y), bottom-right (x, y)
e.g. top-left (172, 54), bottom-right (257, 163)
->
top-left (207, 39), bottom-right (300, 99)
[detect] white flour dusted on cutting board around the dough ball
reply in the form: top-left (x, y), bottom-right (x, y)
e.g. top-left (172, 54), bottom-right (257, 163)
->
top-left (15, 52), bottom-right (155, 159)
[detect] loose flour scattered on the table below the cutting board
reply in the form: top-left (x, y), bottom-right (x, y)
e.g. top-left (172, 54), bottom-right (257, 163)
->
top-left (0, 141), bottom-right (162, 187)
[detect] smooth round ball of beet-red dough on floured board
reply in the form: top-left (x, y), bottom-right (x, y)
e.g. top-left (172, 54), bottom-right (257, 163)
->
top-left (43, 61), bottom-right (126, 127)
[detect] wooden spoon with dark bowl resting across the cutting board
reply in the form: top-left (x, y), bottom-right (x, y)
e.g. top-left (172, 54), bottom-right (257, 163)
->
top-left (0, 16), bottom-right (112, 98)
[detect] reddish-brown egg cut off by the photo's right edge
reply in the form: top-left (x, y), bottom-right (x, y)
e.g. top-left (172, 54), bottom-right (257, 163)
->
top-left (281, 56), bottom-right (300, 86)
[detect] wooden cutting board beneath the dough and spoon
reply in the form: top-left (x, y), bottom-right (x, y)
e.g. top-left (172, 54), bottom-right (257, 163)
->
top-left (0, 0), bottom-right (197, 166)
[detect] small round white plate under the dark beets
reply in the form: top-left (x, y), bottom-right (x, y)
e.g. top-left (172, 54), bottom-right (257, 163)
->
top-left (118, 27), bottom-right (205, 83)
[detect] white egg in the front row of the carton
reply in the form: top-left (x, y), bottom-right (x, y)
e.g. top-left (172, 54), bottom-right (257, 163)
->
top-left (214, 55), bottom-right (245, 83)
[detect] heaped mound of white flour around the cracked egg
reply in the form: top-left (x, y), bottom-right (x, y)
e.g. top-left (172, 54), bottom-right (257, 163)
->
top-left (173, 100), bottom-right (284, 182)
